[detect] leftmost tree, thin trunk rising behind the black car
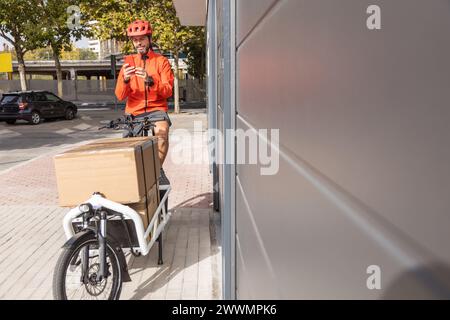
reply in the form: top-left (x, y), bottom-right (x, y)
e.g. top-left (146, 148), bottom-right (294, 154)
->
top-left (0, 0), bottom-right (43, 90)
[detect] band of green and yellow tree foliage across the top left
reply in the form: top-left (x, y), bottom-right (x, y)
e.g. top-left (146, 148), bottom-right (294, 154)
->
top-left (0, 0), bottom-right (205, 70)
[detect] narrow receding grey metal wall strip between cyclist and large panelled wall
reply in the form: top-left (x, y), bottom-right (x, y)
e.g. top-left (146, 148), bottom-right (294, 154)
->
top-left (208, 0), bottom-right (236, 299)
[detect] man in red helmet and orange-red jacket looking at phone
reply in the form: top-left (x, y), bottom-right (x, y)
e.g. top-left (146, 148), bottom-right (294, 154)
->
top-left (116, 20), bottom-right (173, 181)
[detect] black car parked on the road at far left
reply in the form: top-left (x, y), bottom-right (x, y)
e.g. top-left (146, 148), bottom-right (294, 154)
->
top-left (0, 91), bottom-right (77, 124)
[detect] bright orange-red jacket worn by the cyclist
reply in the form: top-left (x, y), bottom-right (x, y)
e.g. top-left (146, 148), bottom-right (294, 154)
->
top-left (116, 51), bottom-right (173, 116)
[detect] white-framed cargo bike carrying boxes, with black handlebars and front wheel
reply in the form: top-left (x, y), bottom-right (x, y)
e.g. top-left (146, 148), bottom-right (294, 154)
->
top-left (53, 115), bottom-right (171, 300)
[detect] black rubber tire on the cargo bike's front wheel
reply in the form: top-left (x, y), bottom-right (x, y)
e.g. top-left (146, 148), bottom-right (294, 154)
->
top-left (53, 234), bottom-right (123, 300)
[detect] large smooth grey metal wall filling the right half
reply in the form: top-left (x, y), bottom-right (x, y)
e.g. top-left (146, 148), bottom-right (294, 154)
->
top-left (234, 0), bottom-right (450, 299)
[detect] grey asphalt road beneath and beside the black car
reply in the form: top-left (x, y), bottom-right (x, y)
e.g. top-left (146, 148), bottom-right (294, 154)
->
top-left (0, 109), bottom-right (206, 172)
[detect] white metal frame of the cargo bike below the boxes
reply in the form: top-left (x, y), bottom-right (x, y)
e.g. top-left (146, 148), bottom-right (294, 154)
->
top-left (63, 185), bottom-right (172, 256)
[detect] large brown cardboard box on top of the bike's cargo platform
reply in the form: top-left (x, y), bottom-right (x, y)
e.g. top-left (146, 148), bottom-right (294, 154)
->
top-left (54, 137), bottom-right (160, 207)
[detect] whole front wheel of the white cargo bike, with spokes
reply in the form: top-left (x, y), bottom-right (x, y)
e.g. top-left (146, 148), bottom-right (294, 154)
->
top-left (53, 234), bottom-right (122, 300)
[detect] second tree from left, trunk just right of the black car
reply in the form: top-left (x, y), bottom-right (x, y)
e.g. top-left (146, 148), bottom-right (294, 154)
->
top-left (38, 0), bottom-right (91, 96)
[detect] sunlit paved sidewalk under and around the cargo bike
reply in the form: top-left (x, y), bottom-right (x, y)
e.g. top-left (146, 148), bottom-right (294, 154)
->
top-left (0, 119), bottom-right (222, 300)
